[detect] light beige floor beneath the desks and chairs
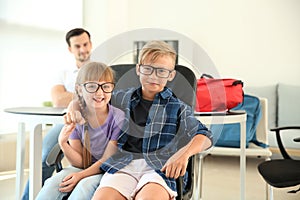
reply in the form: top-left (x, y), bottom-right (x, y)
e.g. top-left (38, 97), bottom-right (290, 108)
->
top-left (0, 156), bottom-right (300, 200)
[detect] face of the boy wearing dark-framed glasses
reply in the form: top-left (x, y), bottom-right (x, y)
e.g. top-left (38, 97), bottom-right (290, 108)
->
top-left (136, 55), bottom-right (176, 100)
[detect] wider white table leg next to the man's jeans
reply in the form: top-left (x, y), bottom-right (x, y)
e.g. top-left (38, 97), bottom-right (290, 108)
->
top-left (29, 124), bottom-right (43, 200)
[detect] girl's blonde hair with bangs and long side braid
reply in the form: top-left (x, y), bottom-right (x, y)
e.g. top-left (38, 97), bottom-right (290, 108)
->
top-left (76, 62), bottom-right (114, 169)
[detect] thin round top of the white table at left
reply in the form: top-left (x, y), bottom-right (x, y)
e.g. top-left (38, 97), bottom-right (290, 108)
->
top-left (4, 107), bottom-right (66, 116)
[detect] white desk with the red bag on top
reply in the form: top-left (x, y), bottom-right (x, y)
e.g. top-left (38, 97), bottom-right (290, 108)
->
top-left (193, 111), bottom-right (247, 200)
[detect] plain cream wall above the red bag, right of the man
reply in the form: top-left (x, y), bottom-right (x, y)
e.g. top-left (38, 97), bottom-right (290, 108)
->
top-left (84, 0), bottom-right (300, 86)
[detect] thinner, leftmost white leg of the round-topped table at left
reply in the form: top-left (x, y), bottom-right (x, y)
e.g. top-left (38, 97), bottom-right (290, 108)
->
top-left (16, 122), bottom-right (26, 200)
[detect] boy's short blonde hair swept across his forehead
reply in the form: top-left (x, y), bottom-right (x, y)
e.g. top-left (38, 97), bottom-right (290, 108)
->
top-left (139, 40), bottom-right (176, 65)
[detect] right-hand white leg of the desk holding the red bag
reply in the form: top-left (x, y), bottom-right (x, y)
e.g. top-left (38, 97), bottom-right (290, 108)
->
top-left (240, 121), bottom-right (246, 200)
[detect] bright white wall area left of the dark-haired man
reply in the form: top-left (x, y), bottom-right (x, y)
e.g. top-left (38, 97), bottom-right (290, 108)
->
top-left (0, 0), bottom-right (82, 134)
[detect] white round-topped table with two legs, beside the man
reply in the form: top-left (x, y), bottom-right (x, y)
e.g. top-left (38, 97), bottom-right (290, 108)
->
top-left (4, 107), bottom-right (65, 199)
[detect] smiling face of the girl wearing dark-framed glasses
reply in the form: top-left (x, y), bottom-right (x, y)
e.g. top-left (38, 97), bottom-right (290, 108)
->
top-left (79, 81), bottom-right (114, 109)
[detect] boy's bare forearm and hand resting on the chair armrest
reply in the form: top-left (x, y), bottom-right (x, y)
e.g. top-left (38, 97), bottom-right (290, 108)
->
top-left (161, 134), bottom-right (211, 179)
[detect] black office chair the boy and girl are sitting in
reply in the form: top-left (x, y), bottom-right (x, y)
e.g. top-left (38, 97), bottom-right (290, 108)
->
top-left (47, 64), bottom-right (198, 200)
